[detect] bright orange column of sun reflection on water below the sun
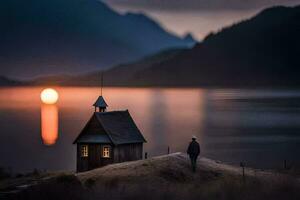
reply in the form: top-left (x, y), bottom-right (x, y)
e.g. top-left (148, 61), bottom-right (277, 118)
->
top-left (41, 104), bottom-right (58, 146)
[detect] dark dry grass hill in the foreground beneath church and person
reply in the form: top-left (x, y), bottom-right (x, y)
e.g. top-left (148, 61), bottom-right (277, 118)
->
top-left (2, 154), bottom-right (300, 200)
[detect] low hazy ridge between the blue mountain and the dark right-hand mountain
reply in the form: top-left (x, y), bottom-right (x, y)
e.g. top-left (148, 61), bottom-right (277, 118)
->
top-left (30, 49), bottom-right (187, 86)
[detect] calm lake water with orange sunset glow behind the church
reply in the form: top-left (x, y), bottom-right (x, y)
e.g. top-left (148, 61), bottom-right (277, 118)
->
top-left (0, 87), bottom-right (300, 172)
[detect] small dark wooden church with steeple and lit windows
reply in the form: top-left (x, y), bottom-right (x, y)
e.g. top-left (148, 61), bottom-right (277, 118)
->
top-left (73, 96), bottom-right (146, 172)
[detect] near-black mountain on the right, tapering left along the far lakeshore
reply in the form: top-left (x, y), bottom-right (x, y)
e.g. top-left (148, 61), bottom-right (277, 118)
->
top-left (2, 6), bottom-right (300, 87)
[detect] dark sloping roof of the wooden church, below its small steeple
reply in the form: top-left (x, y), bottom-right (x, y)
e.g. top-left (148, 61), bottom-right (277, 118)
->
top-left (74, 110), bottom-right (146, 145)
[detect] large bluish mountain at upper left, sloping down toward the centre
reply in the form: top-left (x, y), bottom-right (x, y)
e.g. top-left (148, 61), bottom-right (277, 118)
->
top-left (0, 0), bottom-right (194, 77)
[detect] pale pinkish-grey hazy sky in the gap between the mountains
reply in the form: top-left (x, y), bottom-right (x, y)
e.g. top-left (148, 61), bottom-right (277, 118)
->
top-left (103, 0), bottom-right (300, 39)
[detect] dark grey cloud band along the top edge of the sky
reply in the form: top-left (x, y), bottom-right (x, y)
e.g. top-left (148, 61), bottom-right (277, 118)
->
top-left (104, 0), bottom-right (300, 10)
